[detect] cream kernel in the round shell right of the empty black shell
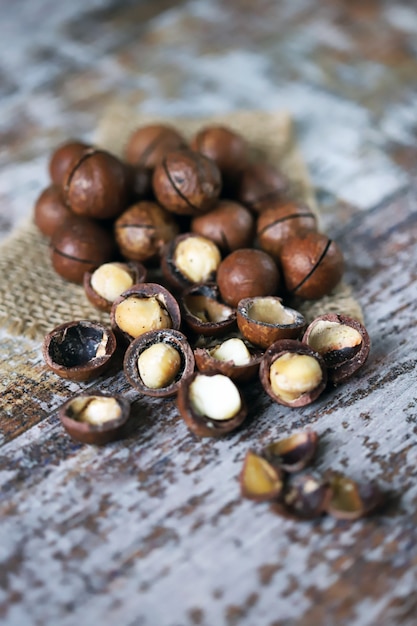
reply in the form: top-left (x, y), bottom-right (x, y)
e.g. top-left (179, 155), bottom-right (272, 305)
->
top-left (138, 342), bottom-right (181, 389)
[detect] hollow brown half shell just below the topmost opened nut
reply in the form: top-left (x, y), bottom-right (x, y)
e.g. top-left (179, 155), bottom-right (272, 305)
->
top-left (180, 283), bottom-right (236, 337)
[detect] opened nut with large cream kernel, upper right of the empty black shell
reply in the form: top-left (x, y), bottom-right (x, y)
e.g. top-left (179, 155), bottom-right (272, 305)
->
top-left (110, 283), bottom-right (181, 343)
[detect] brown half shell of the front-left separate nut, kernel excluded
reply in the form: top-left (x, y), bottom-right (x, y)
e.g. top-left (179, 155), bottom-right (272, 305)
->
top-left (58, 390), bottom-right (130, 445)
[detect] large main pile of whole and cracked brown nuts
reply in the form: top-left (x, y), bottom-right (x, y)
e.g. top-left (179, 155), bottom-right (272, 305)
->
top-left (34, 125), bottom-right (370, 443)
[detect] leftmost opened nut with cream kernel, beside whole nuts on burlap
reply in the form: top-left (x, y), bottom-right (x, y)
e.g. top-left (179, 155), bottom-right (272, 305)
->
top-left (84, 261), bottom-right (147, 312)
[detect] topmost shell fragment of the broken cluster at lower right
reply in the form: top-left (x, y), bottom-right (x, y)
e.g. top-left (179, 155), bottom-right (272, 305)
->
top-left (262, 430), bottom-right (319, 473)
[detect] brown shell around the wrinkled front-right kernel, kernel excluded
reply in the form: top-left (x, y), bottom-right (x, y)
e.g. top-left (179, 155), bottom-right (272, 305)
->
top-left (259, 339), bottom-right (327, 408)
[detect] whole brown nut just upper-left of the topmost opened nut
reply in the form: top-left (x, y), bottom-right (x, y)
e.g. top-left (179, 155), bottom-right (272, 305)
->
top-left (114, 201), bottom-right (179, 263)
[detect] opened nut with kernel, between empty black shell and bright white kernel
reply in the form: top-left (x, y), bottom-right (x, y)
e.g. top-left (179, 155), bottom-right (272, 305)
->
top-left (123, 329), bottom-right (194, 397)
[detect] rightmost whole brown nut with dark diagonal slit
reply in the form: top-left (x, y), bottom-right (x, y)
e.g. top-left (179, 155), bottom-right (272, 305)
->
top-left (280, 232), bottom-right (344, 300)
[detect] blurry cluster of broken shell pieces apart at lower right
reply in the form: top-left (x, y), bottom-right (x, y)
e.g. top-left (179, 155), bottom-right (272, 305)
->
top-left (240, 431), bottom-right (384, 520)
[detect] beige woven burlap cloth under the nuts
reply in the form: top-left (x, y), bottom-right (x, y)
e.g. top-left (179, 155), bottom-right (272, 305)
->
top-left (0, 104), bottom-right (362, 339)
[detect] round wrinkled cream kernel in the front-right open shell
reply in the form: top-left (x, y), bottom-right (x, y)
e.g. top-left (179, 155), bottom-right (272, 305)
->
top-left (269, 353), bottom-right (323, 402)
